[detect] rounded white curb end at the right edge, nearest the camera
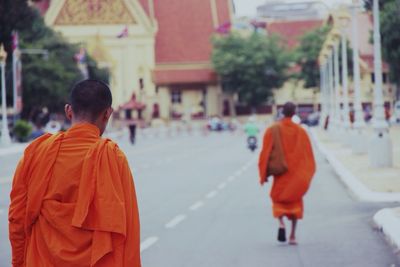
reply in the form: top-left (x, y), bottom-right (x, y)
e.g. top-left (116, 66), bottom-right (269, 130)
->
top-left (374, 208), bottom-right (400, 249)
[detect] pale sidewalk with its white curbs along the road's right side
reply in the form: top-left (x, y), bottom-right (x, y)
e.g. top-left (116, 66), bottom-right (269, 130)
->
top-left (310, 126), bottom-right (400, 249)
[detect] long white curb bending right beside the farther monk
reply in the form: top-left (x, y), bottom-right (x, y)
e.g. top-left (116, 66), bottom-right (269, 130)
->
top-left (307, 129), bottom-right (400, 202)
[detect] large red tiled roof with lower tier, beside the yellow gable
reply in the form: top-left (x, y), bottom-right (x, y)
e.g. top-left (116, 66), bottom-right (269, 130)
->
top-left (154, 0), bottom-right (231, 84)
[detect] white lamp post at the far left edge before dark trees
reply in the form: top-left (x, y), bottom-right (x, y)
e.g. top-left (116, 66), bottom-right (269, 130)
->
top-left (0, 45), bottom-right (11, 146)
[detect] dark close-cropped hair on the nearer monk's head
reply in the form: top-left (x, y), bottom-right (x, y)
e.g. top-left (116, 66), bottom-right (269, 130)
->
top-left (69, 80), bottom-right (112, 121)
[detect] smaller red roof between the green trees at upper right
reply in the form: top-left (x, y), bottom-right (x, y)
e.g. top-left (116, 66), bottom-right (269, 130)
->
top-left (267, 20), bottom-right (324, 49)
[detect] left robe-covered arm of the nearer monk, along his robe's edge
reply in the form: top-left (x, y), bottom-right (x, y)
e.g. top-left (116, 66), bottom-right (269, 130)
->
top-left (8, 159), bottom-right (27, 267)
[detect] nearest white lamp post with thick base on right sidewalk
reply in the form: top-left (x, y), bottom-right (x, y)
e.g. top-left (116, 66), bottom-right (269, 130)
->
top-left (369, 0), bottom-right (393, 167)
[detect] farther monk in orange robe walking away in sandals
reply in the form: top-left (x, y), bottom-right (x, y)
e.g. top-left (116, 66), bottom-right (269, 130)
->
top-left (258, 102), bottom-right (315, 245)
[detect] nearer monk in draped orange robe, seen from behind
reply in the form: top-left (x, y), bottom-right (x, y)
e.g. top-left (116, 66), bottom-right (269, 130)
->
top-left (9, 80), bottom-right (141, 267)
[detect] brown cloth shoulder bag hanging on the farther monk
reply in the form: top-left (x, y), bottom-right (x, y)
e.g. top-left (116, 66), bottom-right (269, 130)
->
top-left (267, 124), bottom-right (288, 177)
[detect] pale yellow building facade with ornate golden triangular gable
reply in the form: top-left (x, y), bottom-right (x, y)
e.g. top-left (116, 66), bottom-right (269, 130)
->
top-left (45, 0), bottom-right (157, 120)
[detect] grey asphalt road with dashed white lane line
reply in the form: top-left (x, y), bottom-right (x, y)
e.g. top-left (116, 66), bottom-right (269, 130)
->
top-left (0, 129), bottom-right (400, 267)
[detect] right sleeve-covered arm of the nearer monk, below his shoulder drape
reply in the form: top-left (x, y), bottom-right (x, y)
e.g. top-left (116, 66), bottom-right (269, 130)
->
top-left (119, 154), bottom-right (141, 267)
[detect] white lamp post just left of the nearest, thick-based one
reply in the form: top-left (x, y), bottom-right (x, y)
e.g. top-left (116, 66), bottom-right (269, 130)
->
top-left (351, 0), bottom-right (367, 154)
